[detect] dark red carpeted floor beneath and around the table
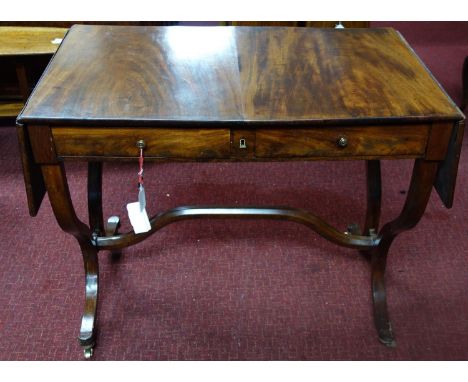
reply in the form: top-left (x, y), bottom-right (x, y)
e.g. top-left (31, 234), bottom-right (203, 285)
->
top-left (0, 21), bottom-right (468, 360)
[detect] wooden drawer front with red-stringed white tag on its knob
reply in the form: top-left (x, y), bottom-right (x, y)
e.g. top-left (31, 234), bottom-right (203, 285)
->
top-left (52, 127), bottom-right (230, 160)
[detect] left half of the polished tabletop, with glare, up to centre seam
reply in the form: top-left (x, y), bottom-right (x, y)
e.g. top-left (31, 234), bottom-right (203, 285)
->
top-left (18, 26), bottom-right (242, 121)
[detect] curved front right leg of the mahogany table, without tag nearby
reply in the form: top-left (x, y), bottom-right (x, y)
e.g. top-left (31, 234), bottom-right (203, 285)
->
top-left (370, 159), bottom-right (438, 347)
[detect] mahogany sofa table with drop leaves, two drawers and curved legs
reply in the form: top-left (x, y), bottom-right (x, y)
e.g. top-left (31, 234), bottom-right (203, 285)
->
top-left (17, 26), bottom-right (464, 357)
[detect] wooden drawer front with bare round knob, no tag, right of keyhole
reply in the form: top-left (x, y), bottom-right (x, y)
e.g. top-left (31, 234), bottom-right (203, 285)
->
top-left (255, 125), bottom-right (429, 158)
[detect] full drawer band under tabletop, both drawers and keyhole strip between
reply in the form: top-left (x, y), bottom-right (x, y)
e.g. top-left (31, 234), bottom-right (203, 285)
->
top-left (47, 124), bottom-right (431, 161)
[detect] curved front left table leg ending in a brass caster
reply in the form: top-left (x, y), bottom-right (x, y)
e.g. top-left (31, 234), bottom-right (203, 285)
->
top-left (42, 163), bottom-right (99, 358)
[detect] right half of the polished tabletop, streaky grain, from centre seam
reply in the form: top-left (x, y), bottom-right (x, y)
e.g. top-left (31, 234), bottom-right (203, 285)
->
top-left (237, 28), bottom-right (457, 120)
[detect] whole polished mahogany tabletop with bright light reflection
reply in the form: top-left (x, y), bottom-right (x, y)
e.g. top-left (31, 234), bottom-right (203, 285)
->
top-left (19, 25), bottom-right (463, 126)
